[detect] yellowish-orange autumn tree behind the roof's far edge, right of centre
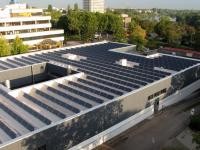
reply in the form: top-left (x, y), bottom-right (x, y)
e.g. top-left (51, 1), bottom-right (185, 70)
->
top-left (129, 25), bottom-right (147, 50)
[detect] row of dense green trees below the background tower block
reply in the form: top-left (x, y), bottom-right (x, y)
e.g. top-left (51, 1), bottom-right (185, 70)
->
top-left (57, 10), bottom-right (125, 41)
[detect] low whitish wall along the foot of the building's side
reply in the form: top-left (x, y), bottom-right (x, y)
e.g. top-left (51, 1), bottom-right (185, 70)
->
top-left (70, 80), bottom-right (200, 150)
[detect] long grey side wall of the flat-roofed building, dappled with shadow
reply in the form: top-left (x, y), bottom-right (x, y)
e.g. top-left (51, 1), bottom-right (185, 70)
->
top-left (1, 63), bottom-right (200, 150)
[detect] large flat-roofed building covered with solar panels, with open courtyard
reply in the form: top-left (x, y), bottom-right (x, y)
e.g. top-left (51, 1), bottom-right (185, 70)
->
top-left (0, 41), bottom-right (200, 150)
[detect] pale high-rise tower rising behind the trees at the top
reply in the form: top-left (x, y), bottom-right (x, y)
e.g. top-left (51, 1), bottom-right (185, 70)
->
top-left (83, 0), bottom-right (105, 13)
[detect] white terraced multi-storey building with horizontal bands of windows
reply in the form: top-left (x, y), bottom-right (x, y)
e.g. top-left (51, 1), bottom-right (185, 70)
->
top-left (0, 0), bottom-right (64, 45)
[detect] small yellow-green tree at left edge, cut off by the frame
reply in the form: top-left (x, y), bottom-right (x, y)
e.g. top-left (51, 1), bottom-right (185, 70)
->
top-left (0, 37), bottom-right (10, 57)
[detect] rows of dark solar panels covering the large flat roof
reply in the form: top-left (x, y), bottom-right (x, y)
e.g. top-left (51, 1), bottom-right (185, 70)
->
top-left (0, 43), bottom-right (198, 143)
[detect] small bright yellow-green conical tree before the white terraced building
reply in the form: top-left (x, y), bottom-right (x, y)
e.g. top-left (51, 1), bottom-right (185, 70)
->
top-left (11, 37), bottom-right (28, 55)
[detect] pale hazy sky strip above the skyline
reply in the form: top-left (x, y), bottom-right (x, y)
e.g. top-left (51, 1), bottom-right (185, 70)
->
top-left (0, 0), bottom-right (200, 10)
